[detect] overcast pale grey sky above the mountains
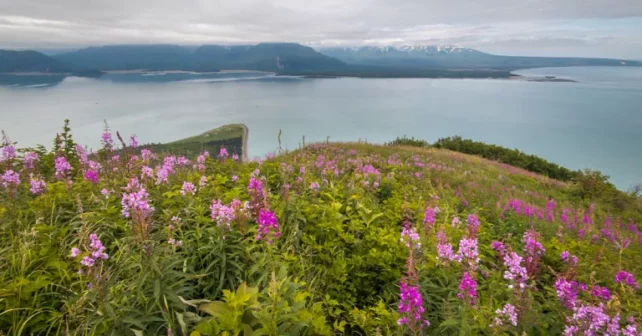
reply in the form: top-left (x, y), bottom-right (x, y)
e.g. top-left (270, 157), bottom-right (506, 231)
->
top-left (0, 0), bottom-right (642, 59)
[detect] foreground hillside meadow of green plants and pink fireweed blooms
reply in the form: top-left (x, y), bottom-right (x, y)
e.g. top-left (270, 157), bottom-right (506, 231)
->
top-left (0, 122), bottom-right (642, 336)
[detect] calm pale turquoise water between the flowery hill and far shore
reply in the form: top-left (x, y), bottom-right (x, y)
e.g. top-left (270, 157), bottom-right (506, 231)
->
top-left (0, 68), bottom-right (642, 189)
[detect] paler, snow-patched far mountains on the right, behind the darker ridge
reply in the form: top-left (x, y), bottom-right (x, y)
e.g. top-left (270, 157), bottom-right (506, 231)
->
top-left (317, 46), bottom-right (642, 71)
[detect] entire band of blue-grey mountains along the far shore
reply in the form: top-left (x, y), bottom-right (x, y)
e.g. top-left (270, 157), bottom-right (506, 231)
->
top-left (0, 43), bottom-right (642, 78)
